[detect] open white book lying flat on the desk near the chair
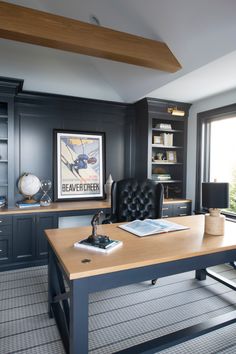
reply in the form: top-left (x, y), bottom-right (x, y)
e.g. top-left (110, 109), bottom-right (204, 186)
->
top-left (119, 219), bottom-right (189, 237)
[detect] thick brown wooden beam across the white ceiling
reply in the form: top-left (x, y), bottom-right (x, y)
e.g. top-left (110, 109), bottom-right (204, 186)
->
top-left (0, 1), bottom-right (181, 72)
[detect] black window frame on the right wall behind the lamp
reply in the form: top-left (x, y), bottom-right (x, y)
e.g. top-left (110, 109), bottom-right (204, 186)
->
top-left (195, 104), bottom-right (236, 213)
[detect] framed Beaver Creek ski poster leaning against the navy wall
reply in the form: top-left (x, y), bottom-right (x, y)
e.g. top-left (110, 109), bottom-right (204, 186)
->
top-left (53, 130), bottom-right (105, 201)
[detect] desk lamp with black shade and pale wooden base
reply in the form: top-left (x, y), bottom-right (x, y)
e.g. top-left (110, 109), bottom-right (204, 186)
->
top-left (202, 182), bottom-right (229, 235)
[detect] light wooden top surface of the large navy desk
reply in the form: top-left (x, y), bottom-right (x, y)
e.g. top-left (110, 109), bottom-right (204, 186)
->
top-left (46, 215), bottom-right (236, 279)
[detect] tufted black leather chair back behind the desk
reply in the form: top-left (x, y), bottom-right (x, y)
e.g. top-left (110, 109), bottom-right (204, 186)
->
top-left (111, 178), bottom-right (164, 222)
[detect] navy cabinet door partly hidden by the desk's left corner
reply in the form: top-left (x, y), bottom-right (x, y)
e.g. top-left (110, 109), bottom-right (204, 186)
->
top-left (36, 214), bottom-right (57, 258)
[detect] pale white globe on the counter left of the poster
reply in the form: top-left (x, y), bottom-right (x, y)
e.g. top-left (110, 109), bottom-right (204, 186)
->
top-left (18, 173), bottom-right (41, 203)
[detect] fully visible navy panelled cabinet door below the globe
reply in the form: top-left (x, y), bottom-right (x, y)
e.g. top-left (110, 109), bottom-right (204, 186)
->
top-left (13, 215), bottom-right (35, 261)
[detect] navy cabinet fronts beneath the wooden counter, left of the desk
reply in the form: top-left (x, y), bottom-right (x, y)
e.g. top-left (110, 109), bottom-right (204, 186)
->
top-left (0, 213), bottom-right (58, 269)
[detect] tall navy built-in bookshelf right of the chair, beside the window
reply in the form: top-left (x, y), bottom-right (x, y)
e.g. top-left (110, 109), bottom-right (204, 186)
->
top-left (136, 98), bottom-right (190, 199)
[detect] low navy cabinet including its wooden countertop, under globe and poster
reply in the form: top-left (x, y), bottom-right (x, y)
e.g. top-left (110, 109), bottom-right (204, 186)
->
top-left (0, 201), bottom-right (110, 271)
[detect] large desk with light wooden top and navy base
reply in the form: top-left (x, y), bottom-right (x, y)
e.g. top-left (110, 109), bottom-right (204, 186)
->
top-left (46, 215), bottom-right (236, 354)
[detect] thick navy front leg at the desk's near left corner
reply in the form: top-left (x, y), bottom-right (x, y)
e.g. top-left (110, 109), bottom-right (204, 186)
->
top-left (70, 278), bottom-right (89, 354)
